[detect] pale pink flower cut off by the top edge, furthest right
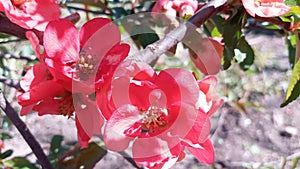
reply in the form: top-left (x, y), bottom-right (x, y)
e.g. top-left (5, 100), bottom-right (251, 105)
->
top-left (242, 0), bottom-right (290, 17)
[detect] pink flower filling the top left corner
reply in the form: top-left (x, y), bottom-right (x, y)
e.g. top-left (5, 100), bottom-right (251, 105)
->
top-left (0, 0), bottom-right (60, 31)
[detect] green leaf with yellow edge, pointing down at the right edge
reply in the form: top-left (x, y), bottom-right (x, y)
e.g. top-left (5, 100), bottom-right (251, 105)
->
top-left (280, 60), bottom-right (300, 107)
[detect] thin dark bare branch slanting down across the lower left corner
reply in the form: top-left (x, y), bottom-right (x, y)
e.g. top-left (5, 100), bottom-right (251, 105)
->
top-left (0, 90), bottom-right (54, 169)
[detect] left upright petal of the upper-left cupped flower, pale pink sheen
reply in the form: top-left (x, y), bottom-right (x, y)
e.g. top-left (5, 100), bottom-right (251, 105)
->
top-left (44, 19), bottom-right (79, 64)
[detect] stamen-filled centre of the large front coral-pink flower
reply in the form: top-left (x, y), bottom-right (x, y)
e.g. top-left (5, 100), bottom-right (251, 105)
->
top-left (142, 106), bottom-right (168, 132)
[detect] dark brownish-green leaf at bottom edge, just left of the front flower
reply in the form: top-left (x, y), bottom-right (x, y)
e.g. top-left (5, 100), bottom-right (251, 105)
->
top-left (76, 142), bottom-right (107, 168)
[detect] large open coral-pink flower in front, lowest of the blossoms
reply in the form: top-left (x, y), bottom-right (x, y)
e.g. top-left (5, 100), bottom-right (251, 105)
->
top-left (101, 61), bottom-right (223, 168)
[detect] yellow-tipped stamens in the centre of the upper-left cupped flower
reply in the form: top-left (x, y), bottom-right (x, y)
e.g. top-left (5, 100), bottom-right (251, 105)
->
top-left (77, 50), bottom-right (97, 74)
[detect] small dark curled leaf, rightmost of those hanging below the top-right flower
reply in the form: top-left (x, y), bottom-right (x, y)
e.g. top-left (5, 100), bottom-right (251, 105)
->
top-left (237, 37), bottom-right (254, 70)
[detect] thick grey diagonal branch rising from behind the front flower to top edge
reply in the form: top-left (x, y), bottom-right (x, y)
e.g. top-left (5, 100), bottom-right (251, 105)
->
top-left (131, 0), bottom-right (227, 63)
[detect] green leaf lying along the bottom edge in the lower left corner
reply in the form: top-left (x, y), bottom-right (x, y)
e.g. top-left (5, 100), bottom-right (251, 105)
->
top-left (3, 157), bottom-right (38, 169)
